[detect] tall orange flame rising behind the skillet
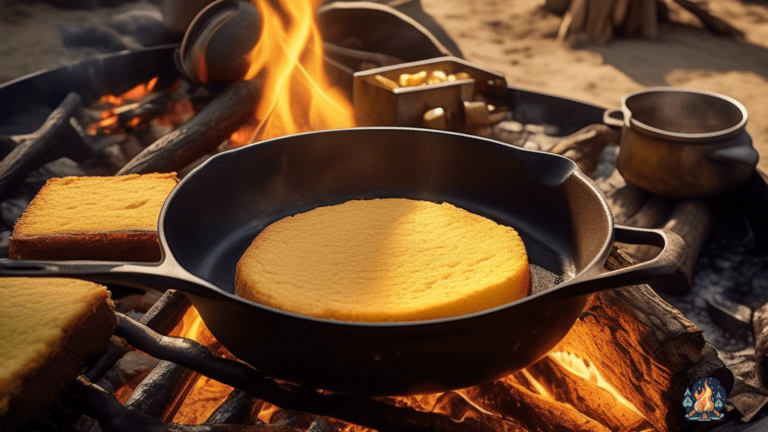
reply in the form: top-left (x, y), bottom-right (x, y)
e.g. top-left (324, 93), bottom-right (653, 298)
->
top-left (231, 0), bottom-right (355, 147)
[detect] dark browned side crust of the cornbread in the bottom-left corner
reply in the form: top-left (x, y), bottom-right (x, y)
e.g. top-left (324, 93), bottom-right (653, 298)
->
top-left (0, 278), bottom-right (117, 431)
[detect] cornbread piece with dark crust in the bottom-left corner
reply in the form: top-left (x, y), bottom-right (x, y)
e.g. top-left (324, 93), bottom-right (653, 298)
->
top-left (0, 277), bottom-right (117, 431)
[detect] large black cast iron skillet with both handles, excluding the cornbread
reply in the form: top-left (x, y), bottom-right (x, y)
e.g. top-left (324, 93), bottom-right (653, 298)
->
top-left (0, 128), bottom-right (684, 395)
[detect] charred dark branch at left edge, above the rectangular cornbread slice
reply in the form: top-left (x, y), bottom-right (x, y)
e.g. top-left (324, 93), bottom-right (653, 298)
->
top-left (0, 93), bottom-right (86, 196)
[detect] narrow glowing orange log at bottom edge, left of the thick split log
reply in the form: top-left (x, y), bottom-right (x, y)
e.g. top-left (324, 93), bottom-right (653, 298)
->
top-left (526, 355), bottom-right (650, 431)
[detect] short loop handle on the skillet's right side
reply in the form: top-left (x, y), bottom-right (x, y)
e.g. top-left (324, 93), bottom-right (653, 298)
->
top-left (549, 225), bottom-right (687, 301)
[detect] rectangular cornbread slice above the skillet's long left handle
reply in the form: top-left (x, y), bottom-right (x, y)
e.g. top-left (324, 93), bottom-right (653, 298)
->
top-left (8, 173), bottom-right (179, 262)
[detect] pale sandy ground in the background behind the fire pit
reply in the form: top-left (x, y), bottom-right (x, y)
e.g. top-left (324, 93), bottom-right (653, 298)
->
top-left (0, 0), bottom-right (768, 171)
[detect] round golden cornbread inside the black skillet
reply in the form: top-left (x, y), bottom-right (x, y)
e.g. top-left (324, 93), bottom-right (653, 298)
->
top-left (235, 198), bottom-right (531, 322)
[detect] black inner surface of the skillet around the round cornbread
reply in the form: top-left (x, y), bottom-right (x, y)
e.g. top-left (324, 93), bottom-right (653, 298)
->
top-left (161, 128), bottom-right (612, 293)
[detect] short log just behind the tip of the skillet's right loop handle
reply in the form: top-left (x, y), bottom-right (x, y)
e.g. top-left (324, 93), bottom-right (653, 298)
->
top-left (651, 200), bottom-right (714, 294)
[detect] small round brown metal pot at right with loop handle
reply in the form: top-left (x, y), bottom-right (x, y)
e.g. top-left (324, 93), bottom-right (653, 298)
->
top-left (603, 87), bottom-right (759, 198)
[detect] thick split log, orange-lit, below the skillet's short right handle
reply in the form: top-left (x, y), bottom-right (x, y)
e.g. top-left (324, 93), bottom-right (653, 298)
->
top-left (555, 248), bottom-right (705, 430)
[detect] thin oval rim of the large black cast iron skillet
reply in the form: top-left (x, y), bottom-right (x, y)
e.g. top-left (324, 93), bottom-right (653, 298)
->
top-left (157, 126), bottom-right (615, 328)
